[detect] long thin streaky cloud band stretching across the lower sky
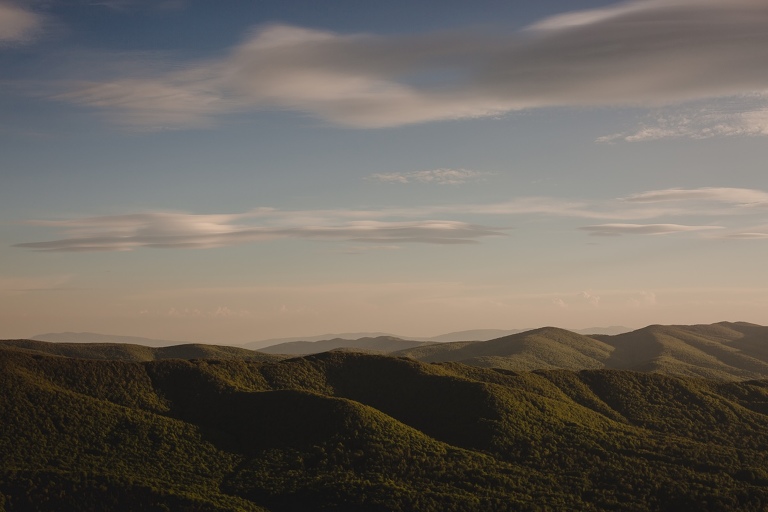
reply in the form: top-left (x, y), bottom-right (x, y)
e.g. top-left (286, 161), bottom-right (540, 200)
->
top-left (16, 187), bottom-right (768, 252)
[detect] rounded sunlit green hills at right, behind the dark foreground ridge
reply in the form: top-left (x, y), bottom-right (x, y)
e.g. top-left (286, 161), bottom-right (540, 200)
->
top-left (392, 322), bottom-right (768, 380)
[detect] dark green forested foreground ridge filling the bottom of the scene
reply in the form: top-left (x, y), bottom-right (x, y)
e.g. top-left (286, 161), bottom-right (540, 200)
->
top-left (0, 344), bottom-right (768, 512)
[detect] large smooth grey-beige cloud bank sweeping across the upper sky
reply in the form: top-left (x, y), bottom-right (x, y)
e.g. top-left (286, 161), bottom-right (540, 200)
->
top-left (56, 0), bottom-right (768, 130)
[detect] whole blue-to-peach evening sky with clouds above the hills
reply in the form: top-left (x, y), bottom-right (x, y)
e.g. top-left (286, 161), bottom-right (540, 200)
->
top-left (0, 0), bottom-right (768, 344)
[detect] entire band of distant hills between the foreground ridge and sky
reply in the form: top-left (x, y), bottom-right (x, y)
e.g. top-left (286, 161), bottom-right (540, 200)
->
top-left (12, 322), bottom-right (768, 380)
